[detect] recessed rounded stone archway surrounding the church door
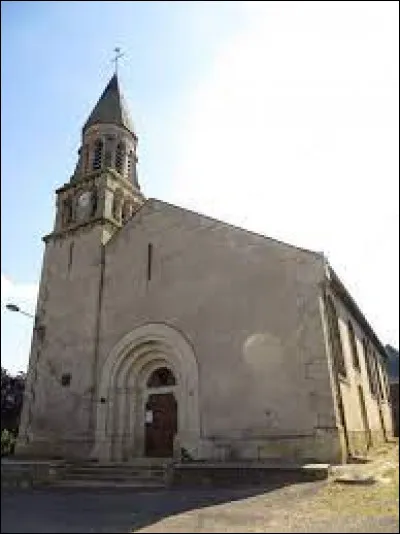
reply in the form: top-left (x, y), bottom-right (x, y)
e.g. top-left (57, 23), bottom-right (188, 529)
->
top-left (91, 323), bottom-right (200, 461)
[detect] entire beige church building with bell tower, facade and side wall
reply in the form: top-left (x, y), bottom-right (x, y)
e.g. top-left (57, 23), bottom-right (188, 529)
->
top-left (16, 75), bottom-right (392, 462)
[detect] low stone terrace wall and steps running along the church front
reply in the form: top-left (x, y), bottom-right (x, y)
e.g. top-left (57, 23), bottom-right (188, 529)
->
top-left (2, 459), bottom-right (332, 489)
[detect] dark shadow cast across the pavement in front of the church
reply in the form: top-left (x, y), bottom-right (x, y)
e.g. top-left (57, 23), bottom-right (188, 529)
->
top-left (1, 479), bottom-right (318, 533)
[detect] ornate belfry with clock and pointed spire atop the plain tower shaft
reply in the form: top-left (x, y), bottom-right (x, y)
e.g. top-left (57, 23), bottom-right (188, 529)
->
top-left (49, 73), bottom-right (145, 244)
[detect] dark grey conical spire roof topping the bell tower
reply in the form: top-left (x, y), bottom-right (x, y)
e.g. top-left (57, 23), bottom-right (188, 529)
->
top-left (83, 74), bottom-right (135, 134)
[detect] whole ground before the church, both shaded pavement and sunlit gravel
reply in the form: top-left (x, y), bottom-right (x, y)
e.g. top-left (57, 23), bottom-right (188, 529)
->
top-left (1, 445), bottom-right (399, 534)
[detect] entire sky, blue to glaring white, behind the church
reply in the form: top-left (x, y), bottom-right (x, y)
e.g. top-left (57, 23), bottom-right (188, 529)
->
top-left (1, 1), bottom-right (399, 371)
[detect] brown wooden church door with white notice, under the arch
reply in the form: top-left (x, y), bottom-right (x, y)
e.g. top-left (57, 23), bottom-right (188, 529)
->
top-left (145, 393), bottom-right (177, 458)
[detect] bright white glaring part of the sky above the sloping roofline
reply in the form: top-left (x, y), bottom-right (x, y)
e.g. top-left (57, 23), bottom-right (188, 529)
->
top-left (169, 2), bottom-right (399, 345)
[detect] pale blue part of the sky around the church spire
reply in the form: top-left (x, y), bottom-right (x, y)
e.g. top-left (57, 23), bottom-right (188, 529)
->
top-left (1, 2), bottom-right (244, 369)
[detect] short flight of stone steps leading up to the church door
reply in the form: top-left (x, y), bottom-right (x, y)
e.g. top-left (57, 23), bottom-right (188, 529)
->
top-left (53, 459), bottom-right (170, 489)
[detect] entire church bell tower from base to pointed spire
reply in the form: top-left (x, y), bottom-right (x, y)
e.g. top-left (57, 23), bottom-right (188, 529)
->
top-left (16, 72), bottom-right (145, 458)
